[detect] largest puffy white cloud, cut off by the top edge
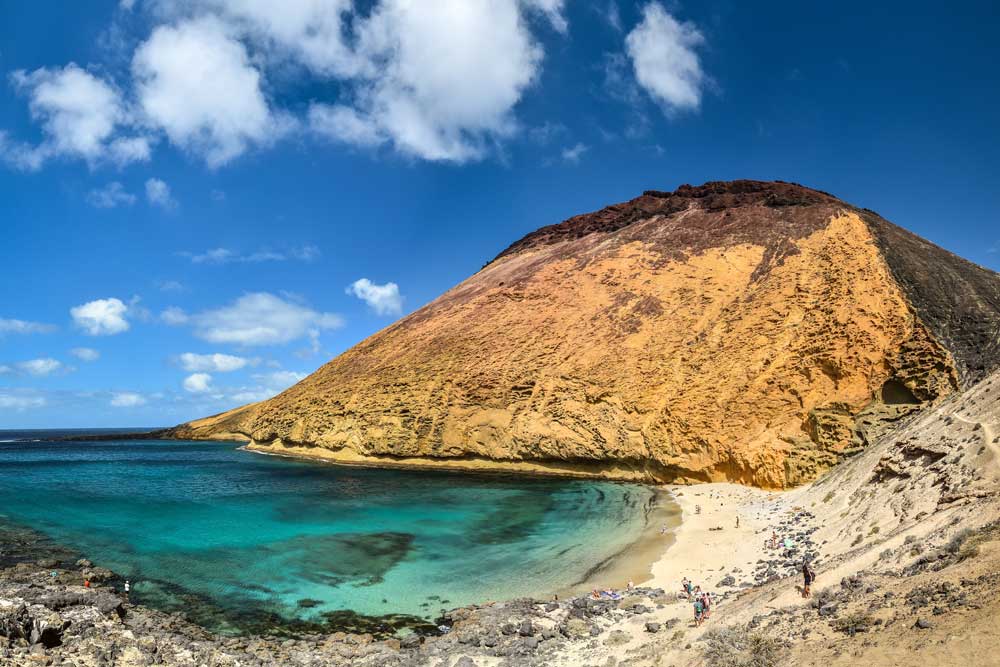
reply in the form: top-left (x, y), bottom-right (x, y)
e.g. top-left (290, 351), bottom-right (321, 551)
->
top-left (309, 0), bottom-right (548, 162)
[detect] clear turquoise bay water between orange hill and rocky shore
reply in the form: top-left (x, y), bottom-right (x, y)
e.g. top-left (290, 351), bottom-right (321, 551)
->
top-left (0, 432), bottom-right (653, 632)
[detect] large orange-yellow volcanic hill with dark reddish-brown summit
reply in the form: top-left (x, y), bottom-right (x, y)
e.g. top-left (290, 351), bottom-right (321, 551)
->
top-left (171, 181), bottom-right (1000, 487)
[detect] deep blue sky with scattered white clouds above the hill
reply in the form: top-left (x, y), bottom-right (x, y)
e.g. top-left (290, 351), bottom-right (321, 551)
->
top-left (0, 0), bottom-right (1000, 428)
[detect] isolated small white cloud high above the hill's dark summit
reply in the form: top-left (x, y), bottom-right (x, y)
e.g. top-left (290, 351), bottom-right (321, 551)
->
top-left (625, 2), bottom-right (706, 112)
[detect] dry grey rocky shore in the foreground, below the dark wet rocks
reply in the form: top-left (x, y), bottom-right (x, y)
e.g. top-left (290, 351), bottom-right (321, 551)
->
top-left (0, 559), bottom-right (696, 667)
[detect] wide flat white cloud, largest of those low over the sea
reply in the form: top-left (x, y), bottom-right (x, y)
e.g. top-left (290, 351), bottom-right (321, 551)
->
top-left (190, 292), bottom-right (343, 345)
